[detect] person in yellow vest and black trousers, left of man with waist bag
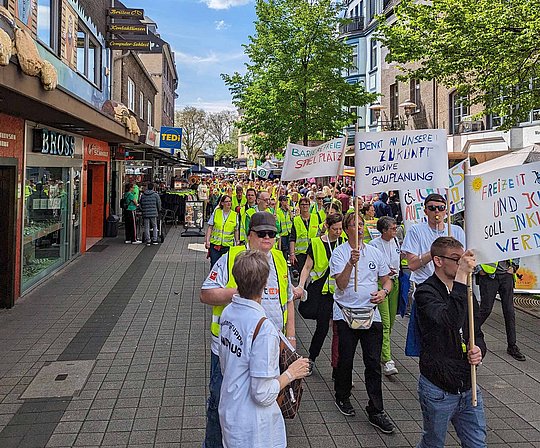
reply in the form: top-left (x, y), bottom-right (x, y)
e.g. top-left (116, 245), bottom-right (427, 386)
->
top-left (294, 213), bottom-right (345, 370)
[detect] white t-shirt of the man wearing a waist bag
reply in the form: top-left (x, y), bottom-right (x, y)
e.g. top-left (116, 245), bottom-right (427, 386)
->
top-left (330, 241), bottom-right (390, 322)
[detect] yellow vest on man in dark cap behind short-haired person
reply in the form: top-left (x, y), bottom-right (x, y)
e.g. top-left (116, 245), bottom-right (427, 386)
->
top-left (210, 246), bottom-right (289, 336)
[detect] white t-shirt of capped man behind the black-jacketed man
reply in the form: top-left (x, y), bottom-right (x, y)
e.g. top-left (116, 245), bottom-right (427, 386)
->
top-left (401, 222), bottom-right (465, 284)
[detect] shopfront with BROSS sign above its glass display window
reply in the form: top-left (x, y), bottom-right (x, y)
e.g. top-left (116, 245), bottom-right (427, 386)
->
top-left (21, 121), bottom-right (83, 293)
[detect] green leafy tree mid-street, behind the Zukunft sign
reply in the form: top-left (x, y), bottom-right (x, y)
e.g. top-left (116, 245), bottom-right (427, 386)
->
top-left (222, 0), bottom-right (376, 155)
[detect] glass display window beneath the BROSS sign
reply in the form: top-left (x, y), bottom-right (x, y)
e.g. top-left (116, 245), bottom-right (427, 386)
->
top-left (22, 167), bottom-right (70, 289)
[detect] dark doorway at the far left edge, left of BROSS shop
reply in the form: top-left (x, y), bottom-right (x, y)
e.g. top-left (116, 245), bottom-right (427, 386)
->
top-left (0, 161), bottom-right (17, 308)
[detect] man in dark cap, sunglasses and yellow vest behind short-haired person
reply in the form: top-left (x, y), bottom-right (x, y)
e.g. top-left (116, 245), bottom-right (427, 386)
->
top-left (200, 212), bottom-right (296, 448)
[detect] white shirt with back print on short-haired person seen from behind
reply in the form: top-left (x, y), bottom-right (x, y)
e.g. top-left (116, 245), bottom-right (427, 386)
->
top-left (218, 295), bottom-right (287, 448)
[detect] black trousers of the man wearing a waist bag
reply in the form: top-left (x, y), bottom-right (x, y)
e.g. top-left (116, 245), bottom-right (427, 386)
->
top-left (334, 320), bottom-right (384, 414)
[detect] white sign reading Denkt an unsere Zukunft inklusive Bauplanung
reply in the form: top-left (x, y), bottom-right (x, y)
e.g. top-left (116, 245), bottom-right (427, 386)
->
top-left (354, 129), bottom-right (448, 194)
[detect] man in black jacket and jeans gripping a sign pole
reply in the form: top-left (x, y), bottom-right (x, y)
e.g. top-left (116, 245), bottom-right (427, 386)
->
top-left (415, 237), bottom-right (487, 448)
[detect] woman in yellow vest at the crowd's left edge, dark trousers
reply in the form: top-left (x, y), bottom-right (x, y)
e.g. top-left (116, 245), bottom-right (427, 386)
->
top-left (204, 194), bottom-right (239, 269)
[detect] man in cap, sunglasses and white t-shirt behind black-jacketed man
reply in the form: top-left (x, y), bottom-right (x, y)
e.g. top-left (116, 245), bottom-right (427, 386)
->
top-left (401, 193), bottom-right (466, 285)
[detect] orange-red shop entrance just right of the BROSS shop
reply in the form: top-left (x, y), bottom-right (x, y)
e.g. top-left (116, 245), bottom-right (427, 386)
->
top-left (86, 163), bottom-right (107, 249)
